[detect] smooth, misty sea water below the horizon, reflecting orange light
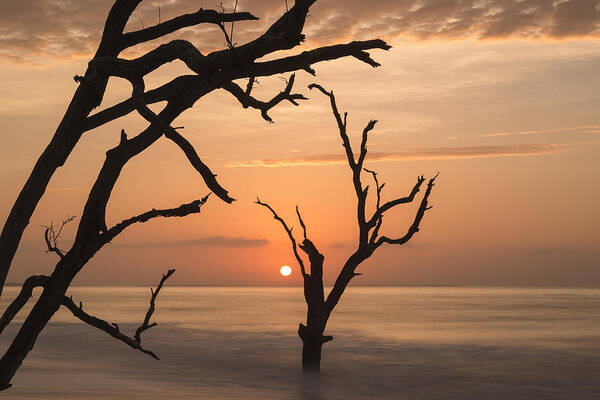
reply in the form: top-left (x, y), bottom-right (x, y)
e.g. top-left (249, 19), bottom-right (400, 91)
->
top-left (0, 287), bottom-right (600, 400)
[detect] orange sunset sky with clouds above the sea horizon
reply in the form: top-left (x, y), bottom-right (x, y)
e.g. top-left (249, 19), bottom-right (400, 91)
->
top-left (0, 0), bottom-right (600, 286)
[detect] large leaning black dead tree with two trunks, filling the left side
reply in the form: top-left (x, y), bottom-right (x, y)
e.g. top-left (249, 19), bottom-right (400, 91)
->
top-left (0, 0), bottom-right (390, 388)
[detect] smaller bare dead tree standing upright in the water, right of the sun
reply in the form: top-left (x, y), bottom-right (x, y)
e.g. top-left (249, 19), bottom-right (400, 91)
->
top-left (256, 84), bottom-right (437, 372)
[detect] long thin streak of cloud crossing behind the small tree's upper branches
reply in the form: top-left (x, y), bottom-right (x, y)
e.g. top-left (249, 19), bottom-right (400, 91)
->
top-left (226, 144), bottom-right (566, 167)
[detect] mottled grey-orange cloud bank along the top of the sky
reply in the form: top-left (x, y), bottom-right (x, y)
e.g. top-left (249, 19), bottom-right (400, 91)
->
top-left (0, 0), bottom-right (600, 63)
